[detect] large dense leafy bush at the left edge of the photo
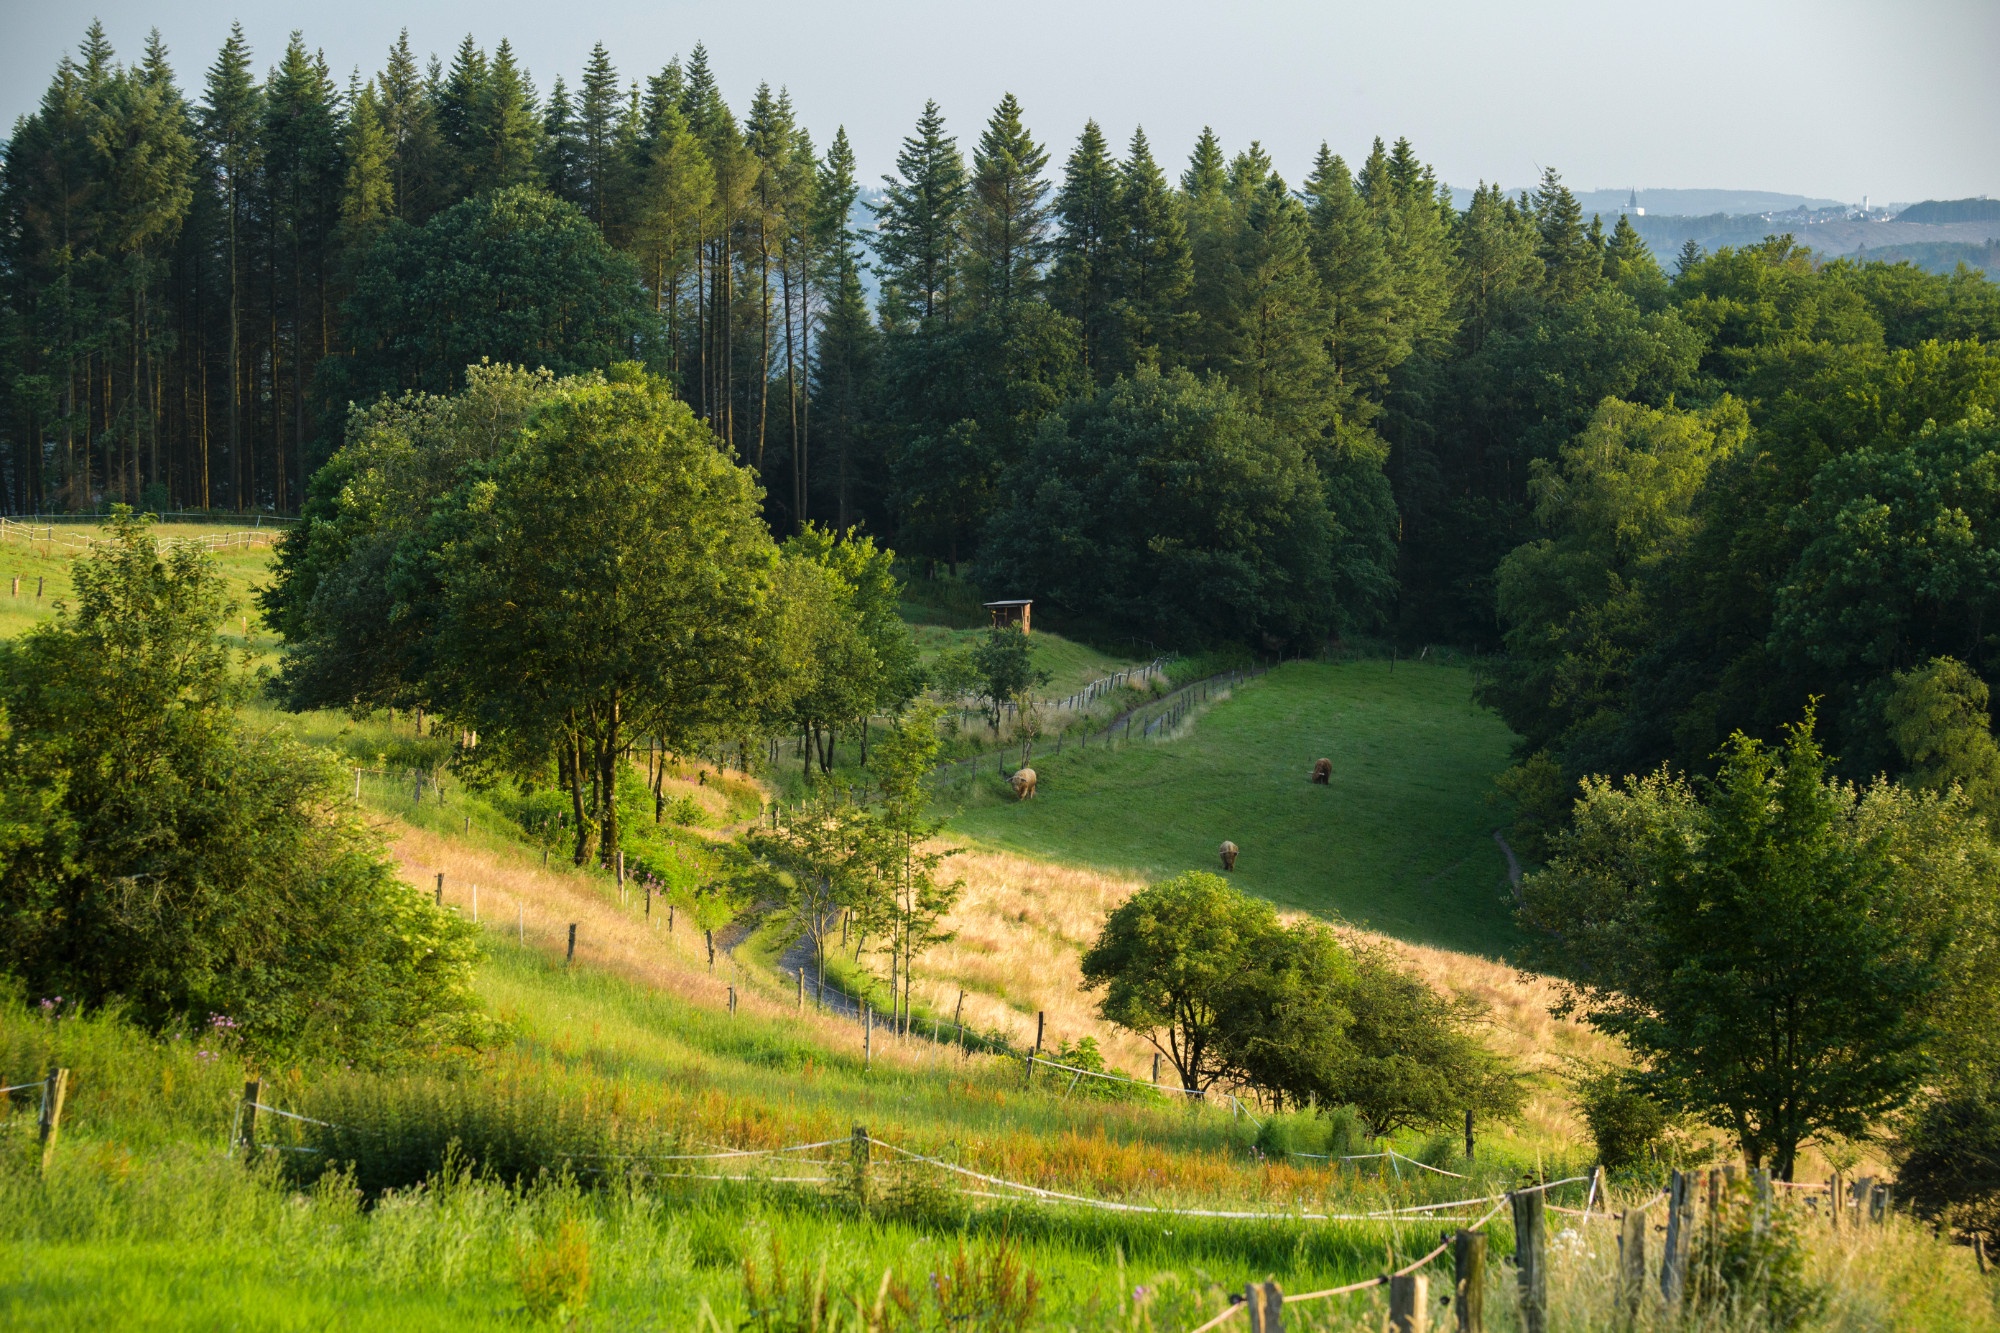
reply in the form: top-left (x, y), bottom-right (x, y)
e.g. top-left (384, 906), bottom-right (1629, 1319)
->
top-left (0, 512), bottom-right (482, 1063)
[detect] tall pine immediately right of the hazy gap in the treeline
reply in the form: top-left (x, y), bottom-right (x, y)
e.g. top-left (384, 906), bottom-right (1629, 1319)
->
top-left (876, 102), bottom-right (966, 324)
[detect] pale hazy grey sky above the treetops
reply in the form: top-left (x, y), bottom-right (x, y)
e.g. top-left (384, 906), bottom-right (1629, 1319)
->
top-left (0, 0), bottom-right (2000, 202)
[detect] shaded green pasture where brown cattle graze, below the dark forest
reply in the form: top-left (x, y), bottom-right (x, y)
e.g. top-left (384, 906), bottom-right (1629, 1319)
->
top-left (950, 660), bottom-right (1516, 957)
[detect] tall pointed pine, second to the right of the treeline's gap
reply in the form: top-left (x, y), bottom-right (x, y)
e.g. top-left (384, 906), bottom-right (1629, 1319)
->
top-left (964, 92), bottom-right (1050, 310)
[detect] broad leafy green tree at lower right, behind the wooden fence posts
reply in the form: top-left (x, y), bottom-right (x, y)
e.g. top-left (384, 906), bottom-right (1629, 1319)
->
top-left (1522, 715), bottom-right (1952, 1179)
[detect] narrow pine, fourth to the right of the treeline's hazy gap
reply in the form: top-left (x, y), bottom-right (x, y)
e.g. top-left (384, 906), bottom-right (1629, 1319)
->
top-left (1104, 130), bottom-right (1184, 376)
